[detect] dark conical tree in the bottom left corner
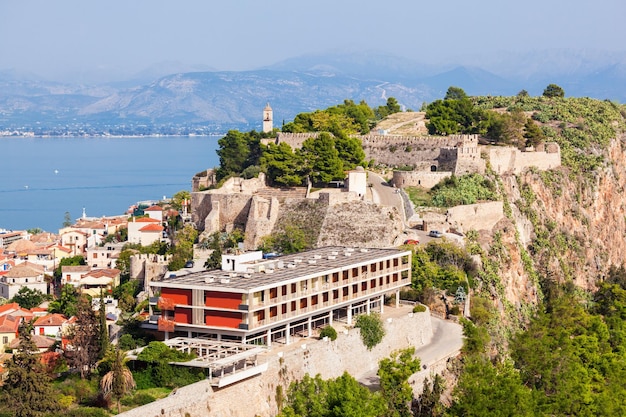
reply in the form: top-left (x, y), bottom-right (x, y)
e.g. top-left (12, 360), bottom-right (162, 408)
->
top-left (2, 323), bottom-right (59, 417)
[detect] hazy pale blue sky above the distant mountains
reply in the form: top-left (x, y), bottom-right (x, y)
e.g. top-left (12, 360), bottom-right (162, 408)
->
top-left (0, 0), bottom-right (626, 78)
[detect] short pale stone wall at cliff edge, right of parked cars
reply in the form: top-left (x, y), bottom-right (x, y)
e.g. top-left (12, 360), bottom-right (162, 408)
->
top-left (446, 201), bottom-right (504, 233)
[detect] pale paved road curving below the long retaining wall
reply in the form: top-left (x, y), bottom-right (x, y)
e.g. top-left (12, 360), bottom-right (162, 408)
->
top-left (359, 316), bottom-right (463, 390)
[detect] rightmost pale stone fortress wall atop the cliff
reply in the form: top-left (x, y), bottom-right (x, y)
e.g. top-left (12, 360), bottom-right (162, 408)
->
top-left (488, 142), bottom-right (561, 175)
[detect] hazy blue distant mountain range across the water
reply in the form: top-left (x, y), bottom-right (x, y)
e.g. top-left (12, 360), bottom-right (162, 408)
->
top-left (0, 50), bottom-right (626, 134)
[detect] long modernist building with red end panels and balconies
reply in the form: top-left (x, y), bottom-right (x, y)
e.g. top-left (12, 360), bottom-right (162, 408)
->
top-left (145, 247), bottom-right (411, 346)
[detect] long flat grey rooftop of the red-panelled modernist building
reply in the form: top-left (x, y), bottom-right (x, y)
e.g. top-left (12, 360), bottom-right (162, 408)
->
top-left (151, 246), bottom-right (411, 292)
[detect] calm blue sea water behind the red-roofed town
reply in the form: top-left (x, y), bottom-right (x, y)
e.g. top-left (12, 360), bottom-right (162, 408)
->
top-left (0, 136), bottom-right (220, 233)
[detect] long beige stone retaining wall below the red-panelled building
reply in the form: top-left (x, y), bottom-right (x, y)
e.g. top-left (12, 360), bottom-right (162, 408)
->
top-left (119, 307), bottom-right (433, 417)
